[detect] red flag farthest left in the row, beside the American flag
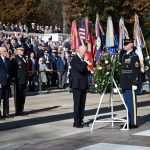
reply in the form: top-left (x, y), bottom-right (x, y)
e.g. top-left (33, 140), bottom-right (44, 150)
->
top-left (71, 21), bottom-right (79, 50)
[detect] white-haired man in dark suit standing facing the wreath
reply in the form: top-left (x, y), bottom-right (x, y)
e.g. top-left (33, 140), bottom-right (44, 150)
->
top-left (71, 46), bottom-right (88, 128)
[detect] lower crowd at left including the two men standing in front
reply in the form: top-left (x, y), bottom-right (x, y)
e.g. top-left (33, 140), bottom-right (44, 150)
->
top-left (0, 28), bottom-right (73, 119)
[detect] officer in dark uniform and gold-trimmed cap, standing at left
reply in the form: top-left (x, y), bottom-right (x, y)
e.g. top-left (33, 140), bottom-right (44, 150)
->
top-left (11, 46), bottom-right (27, 116)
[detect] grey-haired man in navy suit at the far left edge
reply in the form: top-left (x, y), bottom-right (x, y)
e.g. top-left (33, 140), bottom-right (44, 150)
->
top-left (0, 47), bottom-right (10, 118)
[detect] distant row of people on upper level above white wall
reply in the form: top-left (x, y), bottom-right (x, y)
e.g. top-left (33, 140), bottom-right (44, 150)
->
top-left (0, 21), bottom-right (62, 34)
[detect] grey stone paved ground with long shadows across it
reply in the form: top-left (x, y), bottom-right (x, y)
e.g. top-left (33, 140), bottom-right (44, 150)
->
top-left (0, 87), bottom-right (150, 150)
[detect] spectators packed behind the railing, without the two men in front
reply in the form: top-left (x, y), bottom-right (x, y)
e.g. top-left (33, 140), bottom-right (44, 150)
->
top-left (0, 29), bottom-right (72, 91)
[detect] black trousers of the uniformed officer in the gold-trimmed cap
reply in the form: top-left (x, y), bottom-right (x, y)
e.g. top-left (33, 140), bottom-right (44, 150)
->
top-left (15, 84), bottom-right (26, 113)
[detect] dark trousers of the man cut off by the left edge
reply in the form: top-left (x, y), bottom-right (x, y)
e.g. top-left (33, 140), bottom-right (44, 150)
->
top-left (0, 85), bottom-right (10, 115)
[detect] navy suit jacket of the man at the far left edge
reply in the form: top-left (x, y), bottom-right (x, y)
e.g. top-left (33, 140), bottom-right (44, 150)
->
top-left (0, 56), bottom-right (10, 85)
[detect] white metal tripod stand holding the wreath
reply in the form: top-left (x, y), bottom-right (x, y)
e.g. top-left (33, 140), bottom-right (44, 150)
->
top-left (91, 55), bottom-right (129, 131)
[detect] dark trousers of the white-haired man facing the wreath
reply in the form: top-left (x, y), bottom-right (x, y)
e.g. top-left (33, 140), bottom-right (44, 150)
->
top-left (73, 89), bottom-right (86, 124)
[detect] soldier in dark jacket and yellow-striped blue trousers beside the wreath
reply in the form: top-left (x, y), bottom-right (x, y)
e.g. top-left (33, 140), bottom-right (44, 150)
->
top-left (120, 39), bottom-right (140, 128)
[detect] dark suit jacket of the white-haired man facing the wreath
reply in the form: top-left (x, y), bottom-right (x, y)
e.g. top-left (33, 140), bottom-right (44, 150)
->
top-left (70, 55), bottom-right (88, 89)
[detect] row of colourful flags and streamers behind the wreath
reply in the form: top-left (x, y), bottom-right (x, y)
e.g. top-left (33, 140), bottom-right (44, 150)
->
top-left (71, 14), bottom-right (148, 72)
